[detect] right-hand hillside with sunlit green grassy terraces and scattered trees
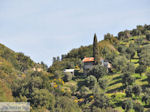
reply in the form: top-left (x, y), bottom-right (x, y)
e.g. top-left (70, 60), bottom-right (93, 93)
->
top-left (49, 25), bottom-right (150, 112)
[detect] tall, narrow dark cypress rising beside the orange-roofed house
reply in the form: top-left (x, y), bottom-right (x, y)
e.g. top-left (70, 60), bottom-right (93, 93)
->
top-left (93, 34), bottom-right (100, 65)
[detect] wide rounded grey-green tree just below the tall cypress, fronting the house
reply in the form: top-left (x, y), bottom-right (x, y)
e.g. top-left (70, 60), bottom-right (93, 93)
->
top-left (88, 65), bottom-right (107, 80)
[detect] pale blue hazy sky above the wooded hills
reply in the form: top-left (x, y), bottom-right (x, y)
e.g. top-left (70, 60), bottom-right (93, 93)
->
top-left (0, 0), bottom-right (150, 66)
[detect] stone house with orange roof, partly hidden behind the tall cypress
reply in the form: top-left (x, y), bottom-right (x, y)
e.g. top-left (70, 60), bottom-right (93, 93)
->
top-left (82, 57), bottom-right (111, 74)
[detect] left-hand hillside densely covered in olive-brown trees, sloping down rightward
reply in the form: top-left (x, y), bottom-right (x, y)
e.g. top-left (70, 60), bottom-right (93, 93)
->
top-left (0, 44), bottom-right (81, 112)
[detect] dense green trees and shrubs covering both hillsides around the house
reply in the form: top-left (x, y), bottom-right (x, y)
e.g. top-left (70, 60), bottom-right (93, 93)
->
top-left (0, 25), bottom-right (150, 112)
